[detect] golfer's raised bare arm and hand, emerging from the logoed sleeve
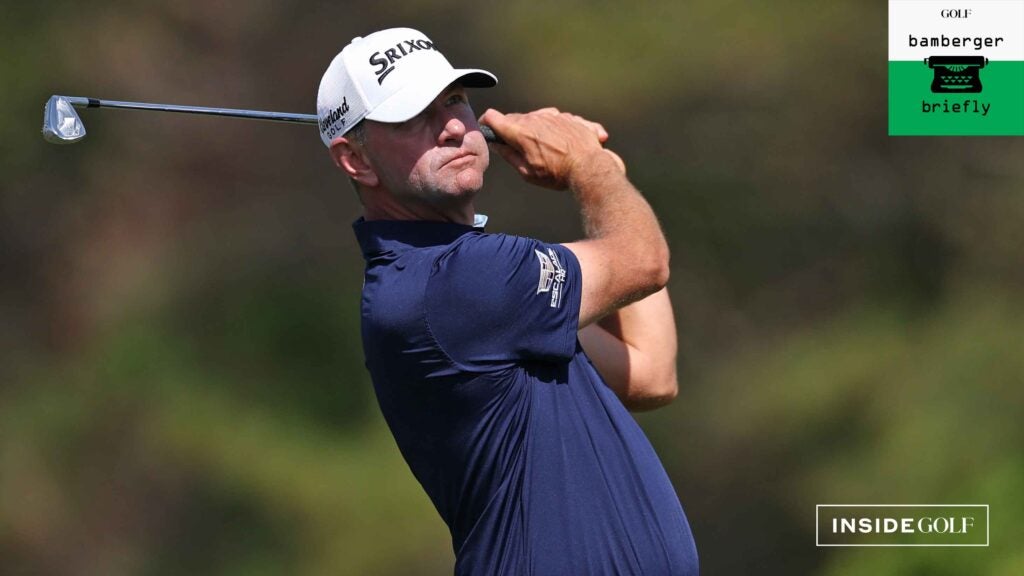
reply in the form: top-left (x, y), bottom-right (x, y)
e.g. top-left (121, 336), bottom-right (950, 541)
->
top-left (480, 109), bottom-right (669, 328)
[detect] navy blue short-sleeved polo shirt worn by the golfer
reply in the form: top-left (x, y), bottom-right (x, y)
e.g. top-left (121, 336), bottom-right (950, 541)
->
top-left (353, 219), bottom-right (697, 576)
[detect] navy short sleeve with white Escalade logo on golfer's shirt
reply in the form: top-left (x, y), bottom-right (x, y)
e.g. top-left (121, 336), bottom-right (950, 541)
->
top-left (426, 233), bottom-right (582, 370)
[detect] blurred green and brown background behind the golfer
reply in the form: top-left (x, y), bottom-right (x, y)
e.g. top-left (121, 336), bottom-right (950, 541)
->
top-left (0, 0), bottom-right (1024, 576)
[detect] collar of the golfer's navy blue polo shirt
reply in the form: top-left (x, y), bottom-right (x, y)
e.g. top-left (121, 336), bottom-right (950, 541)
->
top-left (352, 214), bottom-right (487, 259)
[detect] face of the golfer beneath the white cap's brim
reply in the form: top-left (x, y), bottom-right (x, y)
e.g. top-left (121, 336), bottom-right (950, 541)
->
top-left (366, 83), bottom-right (489, 204)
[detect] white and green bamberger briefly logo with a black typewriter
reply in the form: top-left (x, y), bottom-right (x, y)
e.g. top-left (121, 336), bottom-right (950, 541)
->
top-left (889, 0), bottom-right (1024, 135)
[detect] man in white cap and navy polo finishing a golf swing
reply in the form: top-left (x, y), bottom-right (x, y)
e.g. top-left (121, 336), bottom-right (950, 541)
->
top-left (317, 29), bottom-right (697, 575)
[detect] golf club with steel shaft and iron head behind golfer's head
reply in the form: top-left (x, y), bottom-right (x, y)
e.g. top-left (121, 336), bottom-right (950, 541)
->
top-left (43, 95), bottom-right (504, 143)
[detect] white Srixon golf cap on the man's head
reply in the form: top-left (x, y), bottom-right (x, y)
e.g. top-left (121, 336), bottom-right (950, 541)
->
top-left (316, 28), bottom-right (498, 148)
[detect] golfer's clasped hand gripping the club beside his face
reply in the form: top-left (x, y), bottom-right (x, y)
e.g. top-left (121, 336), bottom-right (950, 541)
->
top-left (480, 108), bottom-right (626, 190)
